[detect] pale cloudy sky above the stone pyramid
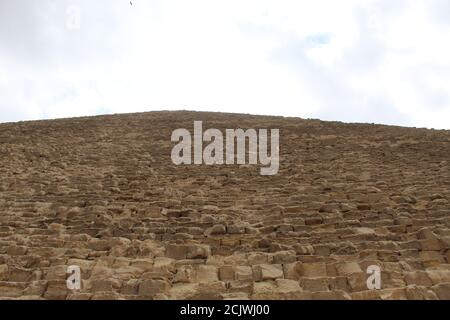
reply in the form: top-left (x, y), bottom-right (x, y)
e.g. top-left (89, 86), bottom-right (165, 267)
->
top-left (0, 0), bottom-right (450, 129)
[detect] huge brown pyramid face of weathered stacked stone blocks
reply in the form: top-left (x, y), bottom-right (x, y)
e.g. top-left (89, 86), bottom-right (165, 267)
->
top-left (0, 112), bottom-right (450, 300)
